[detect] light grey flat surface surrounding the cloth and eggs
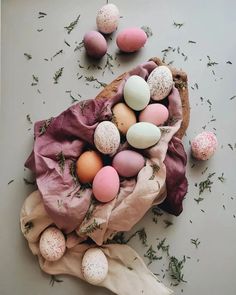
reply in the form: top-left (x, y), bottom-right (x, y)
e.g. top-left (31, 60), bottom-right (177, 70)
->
top-left (0, 0), bottom-right (236, 295)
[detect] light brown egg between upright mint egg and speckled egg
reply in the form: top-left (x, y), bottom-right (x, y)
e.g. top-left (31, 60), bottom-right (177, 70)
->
top-left (112, 102), bottom-right (137, 134)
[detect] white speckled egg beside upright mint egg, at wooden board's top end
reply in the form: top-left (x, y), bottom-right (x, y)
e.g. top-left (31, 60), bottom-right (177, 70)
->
top-left (147, 66), bottom-right (174, 100)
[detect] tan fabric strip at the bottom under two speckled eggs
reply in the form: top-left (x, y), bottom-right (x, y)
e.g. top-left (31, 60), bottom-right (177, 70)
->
top-left (20, 191), bottom-right (172, 295)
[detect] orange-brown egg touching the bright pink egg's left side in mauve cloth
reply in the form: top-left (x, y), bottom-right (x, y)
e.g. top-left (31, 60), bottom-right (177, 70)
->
top-left (76, 151), bottom-right (103, 183)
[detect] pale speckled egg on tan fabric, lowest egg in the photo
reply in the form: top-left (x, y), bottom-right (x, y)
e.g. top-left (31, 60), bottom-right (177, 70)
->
top-left (82, 248), bottom-right (108, 285)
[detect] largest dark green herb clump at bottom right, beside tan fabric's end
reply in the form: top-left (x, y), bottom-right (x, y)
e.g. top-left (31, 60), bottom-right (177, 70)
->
top-left (168, 256), bottom-right (186, 286)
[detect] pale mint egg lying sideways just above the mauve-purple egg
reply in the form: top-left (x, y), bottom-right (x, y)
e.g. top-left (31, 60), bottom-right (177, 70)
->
top-left (126, 122), bottom-right (161, 149)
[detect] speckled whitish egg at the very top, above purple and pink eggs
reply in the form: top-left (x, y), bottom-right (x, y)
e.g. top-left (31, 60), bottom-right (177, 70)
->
top-left (96, 3), bottom-right (120, 34)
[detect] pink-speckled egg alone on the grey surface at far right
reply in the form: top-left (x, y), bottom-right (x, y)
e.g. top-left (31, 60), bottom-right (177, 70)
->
top-left (191, 131), bottom-right (218, 161)
